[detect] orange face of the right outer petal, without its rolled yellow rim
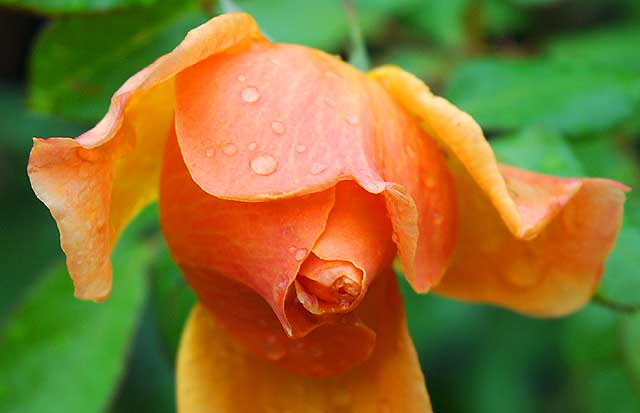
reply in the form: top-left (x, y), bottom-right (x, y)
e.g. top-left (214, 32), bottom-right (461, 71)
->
top-left (435, 167), bottom-right (625, 316)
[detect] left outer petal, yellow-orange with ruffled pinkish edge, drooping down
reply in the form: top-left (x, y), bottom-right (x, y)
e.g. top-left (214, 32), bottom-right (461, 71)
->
top-left (28, 14), bottom-right (265, 301)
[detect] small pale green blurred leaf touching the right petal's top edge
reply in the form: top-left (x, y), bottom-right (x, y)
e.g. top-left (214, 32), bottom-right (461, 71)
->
top-left (491, 128), bottom-right (584, 176)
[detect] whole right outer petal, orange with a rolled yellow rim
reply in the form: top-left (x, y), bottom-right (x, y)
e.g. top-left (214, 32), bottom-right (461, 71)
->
top-left (373, 67), bottom-right (627, 316)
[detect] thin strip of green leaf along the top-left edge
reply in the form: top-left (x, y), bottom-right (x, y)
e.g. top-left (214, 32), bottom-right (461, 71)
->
top-left (0, 0), bottom-right (159, 14)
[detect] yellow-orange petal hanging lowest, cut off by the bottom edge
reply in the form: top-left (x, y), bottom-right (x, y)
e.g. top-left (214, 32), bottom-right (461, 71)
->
top-left (177, 276), bottom-right (431, 413)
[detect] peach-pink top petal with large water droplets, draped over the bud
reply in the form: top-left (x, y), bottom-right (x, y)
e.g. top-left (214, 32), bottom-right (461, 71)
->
top-left (176, 44), bottom-right (455, 289)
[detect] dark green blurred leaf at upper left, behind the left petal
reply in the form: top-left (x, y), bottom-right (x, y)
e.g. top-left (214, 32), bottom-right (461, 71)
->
top-left (29, 0), bottom-right (205, 122)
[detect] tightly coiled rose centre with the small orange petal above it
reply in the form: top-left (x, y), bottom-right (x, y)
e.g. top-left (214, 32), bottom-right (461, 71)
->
top-left (296, 181), bottom-right (395, 314)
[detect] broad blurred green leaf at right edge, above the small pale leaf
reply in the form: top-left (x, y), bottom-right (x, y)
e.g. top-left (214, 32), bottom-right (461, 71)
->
top-left (446, 59), bottom-right (640, 134)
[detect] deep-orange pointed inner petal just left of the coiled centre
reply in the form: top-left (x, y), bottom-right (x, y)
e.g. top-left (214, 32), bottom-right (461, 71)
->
top-left (160, 129), bottom-right (334, 334)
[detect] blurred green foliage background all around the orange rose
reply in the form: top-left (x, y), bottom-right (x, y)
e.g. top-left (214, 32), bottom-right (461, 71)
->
top-left (0, 0), bottom-right (640, 413)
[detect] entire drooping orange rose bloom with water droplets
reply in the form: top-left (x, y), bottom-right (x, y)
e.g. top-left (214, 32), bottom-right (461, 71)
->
top-left (28, 14), bottom-right (627, 413)
